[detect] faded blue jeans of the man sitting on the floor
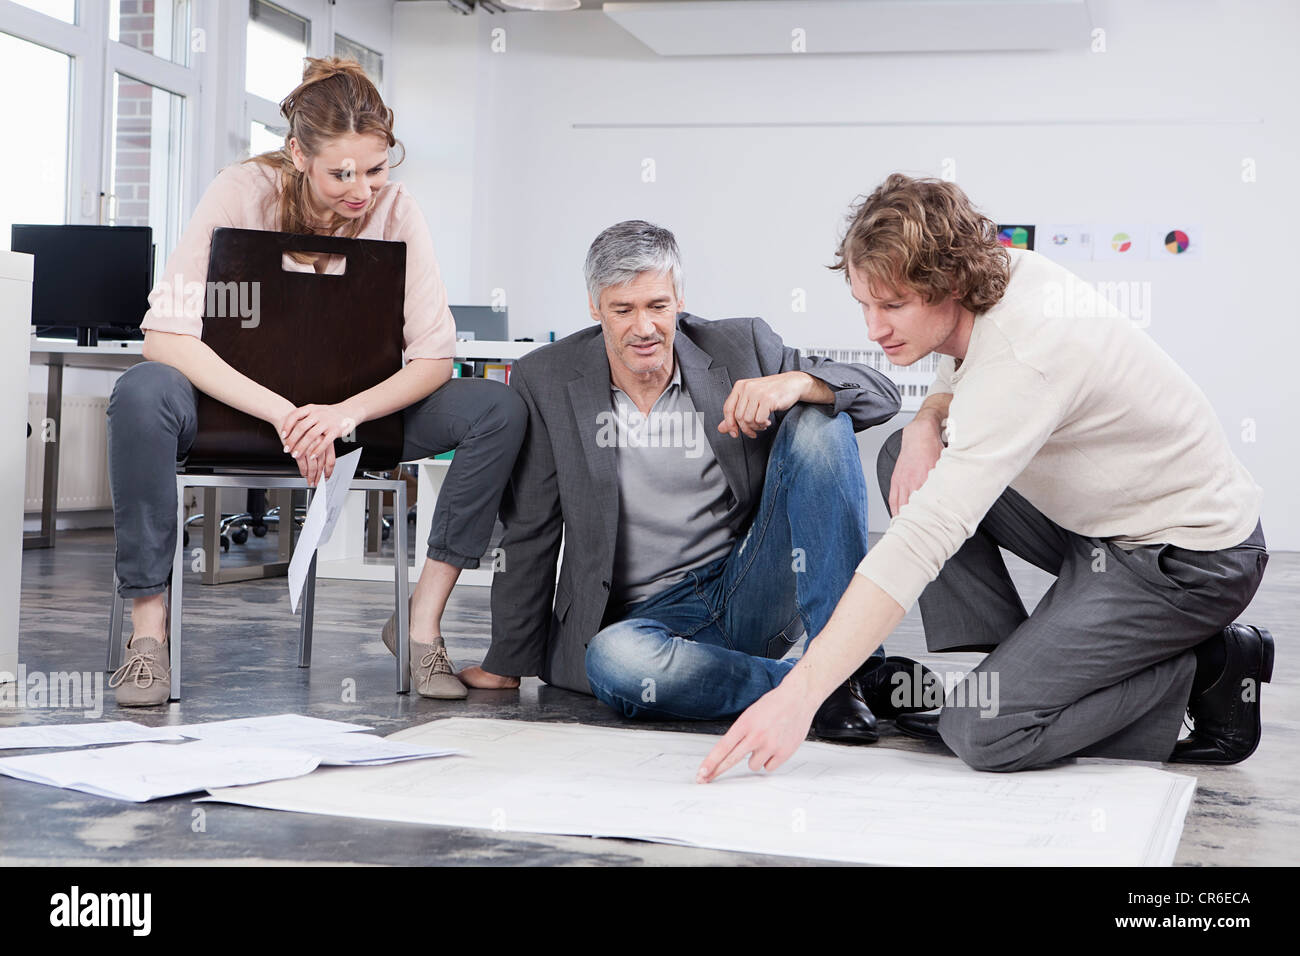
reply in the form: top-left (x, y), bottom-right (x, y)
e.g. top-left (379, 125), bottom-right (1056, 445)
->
top-left (586, 405), bottom-right (885, 721)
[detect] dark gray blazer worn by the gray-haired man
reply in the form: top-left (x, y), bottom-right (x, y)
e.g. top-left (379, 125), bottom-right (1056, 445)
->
top-left (482, 312), bottom-right (900, 693)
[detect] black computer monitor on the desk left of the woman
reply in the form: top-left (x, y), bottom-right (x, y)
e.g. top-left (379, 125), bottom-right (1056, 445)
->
top-left (10, 224), bottom-right (153, 345)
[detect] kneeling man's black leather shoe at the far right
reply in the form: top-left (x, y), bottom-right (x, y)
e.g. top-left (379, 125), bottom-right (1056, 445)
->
top-left (1169, 624), bottom-right (1273, 763)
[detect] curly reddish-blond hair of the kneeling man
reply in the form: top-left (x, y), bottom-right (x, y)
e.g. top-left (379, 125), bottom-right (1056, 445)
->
top-left (828, 173), bottom-right (1010, 315)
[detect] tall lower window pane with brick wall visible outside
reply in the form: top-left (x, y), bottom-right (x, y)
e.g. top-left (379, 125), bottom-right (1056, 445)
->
top-left (108, 73), bottom-right (185, 274)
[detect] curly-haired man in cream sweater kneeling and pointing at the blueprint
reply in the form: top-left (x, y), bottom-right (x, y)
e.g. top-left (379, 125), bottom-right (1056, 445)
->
top-left (701, 174), bottom-right (1273, 780)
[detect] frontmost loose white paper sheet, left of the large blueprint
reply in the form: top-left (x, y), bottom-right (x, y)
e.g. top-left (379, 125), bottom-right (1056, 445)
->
top-left (0, 741), bottom-right (320, 803)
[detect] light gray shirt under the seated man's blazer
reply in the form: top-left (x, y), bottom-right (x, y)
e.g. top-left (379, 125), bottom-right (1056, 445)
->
top-left (598, 362), bottom-right (736, 605)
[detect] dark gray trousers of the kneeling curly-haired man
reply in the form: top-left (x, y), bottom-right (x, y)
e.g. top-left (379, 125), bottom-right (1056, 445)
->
top-left (876, 431), bottom-right (1269, 770)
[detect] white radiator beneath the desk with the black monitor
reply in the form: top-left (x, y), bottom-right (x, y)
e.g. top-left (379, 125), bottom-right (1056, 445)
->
top-left (23, 393), bottom-right (113, 512)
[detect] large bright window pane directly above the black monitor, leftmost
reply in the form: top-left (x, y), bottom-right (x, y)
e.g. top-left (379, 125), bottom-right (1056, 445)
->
top-left (0, 33), bottom-right (72, 248)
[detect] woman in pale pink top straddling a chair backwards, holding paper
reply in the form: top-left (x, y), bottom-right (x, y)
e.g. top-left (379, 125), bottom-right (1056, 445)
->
top-left (108, 57), bottom-right (527, 706)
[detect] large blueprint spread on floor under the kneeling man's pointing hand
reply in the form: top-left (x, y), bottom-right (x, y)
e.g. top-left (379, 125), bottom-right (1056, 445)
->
top-left (212, 718), bottom-right (1196, 866)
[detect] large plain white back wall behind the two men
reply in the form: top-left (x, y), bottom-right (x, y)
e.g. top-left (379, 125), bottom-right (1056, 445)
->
top-left (391, 0), bottom-right (1300, 550)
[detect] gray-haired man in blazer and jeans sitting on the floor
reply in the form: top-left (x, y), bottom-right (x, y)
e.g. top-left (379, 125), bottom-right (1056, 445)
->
top-left (462, 221), bottom-right (930, 743)
